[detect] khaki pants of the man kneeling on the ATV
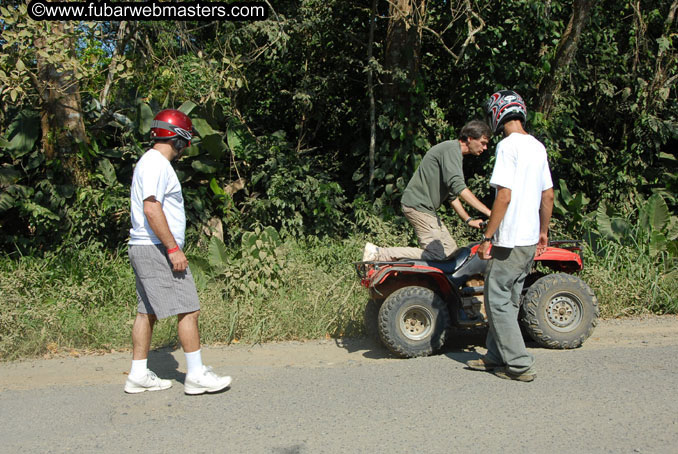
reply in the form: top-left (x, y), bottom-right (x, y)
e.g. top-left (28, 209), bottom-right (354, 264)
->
top-left (377, 205), bottom-right (457, 261)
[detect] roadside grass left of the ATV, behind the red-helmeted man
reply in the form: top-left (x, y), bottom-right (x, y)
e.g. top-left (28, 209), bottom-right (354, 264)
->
top-left (0, 240), bottom-right (365, 360)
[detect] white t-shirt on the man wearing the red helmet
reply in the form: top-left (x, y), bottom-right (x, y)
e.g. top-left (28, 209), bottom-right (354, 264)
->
top-left (129, 148), bottom-right (186, 247)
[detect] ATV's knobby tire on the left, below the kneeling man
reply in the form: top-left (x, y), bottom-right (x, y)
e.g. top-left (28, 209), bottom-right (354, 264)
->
top-left (378, 286), bottom-right (450, 358)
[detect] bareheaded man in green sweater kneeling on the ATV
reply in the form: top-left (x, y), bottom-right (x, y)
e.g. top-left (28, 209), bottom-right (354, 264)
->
top-left (363, 120), bottom-right (491, 262)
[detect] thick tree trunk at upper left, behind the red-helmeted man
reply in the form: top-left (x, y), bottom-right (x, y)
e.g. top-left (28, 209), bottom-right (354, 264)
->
top-left (35, 22), bottom-right (89, 185)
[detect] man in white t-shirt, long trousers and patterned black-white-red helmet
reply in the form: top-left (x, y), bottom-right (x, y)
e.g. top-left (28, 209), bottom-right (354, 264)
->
top-left (467, 90), bottom-right (553, 381)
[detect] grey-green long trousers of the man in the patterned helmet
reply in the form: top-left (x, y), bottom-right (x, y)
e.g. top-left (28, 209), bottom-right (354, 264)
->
top-left (485, 246), bottom-right (534, 374)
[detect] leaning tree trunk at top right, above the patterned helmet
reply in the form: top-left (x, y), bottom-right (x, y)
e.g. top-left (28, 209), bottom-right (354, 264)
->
top-left (537, 0), bottom-right (596, 116)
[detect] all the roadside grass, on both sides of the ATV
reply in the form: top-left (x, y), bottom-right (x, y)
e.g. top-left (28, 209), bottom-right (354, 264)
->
top-left (0, 221), bottom-right (678, 360)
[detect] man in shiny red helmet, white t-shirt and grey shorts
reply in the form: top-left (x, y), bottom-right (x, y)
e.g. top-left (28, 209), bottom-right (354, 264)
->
top-left (125, 109), bottom-right (231, 394)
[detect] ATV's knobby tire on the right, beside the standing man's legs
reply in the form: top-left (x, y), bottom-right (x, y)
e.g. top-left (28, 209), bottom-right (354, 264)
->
top-left (521, 273), bottom-right (599, 349)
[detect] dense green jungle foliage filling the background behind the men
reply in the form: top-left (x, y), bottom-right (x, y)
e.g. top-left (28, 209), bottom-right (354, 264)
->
top-left (0, 0), bottom-right (678, 316)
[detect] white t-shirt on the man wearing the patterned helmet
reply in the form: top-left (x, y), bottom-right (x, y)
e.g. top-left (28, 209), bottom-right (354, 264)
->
top-left (490, 133), bottom-right (553, 248)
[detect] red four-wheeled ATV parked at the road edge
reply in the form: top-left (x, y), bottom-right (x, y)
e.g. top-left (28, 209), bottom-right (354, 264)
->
top-left (354, 240), bottom-right (599, 358)
